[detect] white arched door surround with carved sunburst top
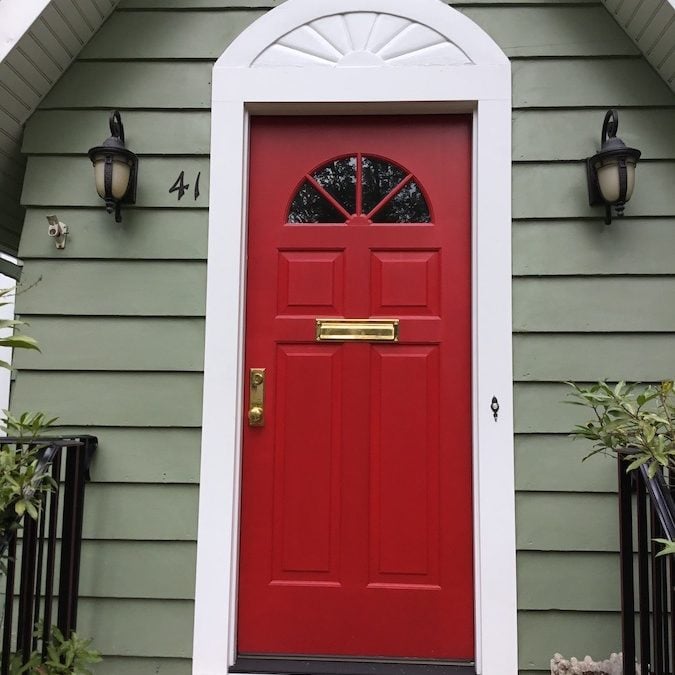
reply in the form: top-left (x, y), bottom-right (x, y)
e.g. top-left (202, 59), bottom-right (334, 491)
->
top-left (192, 0), bottom-right (518, 675)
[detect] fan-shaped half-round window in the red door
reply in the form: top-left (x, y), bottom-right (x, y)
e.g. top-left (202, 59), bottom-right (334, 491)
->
top-left (287, 153), bottom-right (431, 223)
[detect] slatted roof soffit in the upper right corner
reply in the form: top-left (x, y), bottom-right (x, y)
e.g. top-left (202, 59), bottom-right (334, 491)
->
top-left (602, 0), bottom-right (675, 92)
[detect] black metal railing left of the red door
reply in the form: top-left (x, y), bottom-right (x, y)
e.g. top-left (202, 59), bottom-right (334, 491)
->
top-left (0, 436), bottom-right (98, 675)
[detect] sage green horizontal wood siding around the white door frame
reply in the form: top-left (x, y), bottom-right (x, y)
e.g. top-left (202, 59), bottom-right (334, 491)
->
top-left (13, 0), bottom-right (675, 675)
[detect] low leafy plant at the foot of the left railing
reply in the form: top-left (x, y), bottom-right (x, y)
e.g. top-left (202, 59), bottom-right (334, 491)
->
top-left (10, 626), bottom-right (101, 675)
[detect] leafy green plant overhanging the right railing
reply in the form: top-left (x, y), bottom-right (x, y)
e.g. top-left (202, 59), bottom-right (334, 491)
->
top-left (568, 380), bottom-right (675, 555)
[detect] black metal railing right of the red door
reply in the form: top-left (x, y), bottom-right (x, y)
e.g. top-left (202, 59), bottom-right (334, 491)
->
top-left (619, 457), bottom-right (675, 675)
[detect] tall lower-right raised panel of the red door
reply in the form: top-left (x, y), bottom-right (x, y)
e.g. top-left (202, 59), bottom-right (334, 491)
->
top-left (369, 345), bottom-right (440, 590)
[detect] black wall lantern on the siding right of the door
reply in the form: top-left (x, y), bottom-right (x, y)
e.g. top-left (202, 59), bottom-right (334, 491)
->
top-left (586, 110), bottom-right (642, 225)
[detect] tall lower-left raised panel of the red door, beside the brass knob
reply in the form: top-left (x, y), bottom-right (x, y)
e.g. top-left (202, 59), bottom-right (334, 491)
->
top-left (272, 345), bottom-right (342, 583)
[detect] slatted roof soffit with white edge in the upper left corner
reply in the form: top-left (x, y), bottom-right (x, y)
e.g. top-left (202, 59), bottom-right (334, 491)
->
top-left (0, 0), bottom-right (119, 252)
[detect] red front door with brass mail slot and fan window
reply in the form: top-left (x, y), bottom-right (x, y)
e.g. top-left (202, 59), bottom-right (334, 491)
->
top-left (237, 115), bottom-right (474, 661)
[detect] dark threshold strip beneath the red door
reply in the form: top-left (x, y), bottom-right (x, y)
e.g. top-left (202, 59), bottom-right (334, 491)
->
top-left (229, 656), bottom-right (476, 675)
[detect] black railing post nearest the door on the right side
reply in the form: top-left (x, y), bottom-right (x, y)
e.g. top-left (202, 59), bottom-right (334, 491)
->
top-left (617, 455), bottom-right (635, 675)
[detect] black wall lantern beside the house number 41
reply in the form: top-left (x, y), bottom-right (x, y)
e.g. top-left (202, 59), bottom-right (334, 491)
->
top-left (89, 110), bottom-right (138, 223)
